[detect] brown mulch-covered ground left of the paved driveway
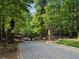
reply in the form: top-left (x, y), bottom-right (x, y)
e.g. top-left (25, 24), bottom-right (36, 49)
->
top-left (0, 43), bottom-right (17, 59)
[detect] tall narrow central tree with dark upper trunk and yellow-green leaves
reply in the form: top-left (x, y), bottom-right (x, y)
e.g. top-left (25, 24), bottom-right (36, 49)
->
top-left (35, 0), bottom-right (47, 39)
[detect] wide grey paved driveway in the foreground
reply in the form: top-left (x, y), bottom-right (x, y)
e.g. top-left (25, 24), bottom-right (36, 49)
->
top-left (18, 41), bottom-right (79, 59)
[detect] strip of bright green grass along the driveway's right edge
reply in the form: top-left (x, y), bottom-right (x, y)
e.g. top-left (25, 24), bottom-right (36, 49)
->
top-left (57, 39), bottom-right (79, 48)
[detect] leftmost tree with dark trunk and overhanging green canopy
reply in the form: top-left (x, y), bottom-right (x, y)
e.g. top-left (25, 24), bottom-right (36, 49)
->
top-left (0, 0), bottom-right (33, 41)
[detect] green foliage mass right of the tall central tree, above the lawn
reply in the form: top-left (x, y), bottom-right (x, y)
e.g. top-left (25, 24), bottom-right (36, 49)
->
top-left (43, 0), bottom-right (77, 32)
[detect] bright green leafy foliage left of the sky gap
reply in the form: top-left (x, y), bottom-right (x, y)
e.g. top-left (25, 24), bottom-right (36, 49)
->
top-left (0, 0), bottom-right (33, 33)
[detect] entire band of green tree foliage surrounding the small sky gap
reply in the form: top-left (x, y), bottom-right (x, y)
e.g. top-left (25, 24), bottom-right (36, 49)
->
top-left (0, 0), bottom-right (79, 36)
